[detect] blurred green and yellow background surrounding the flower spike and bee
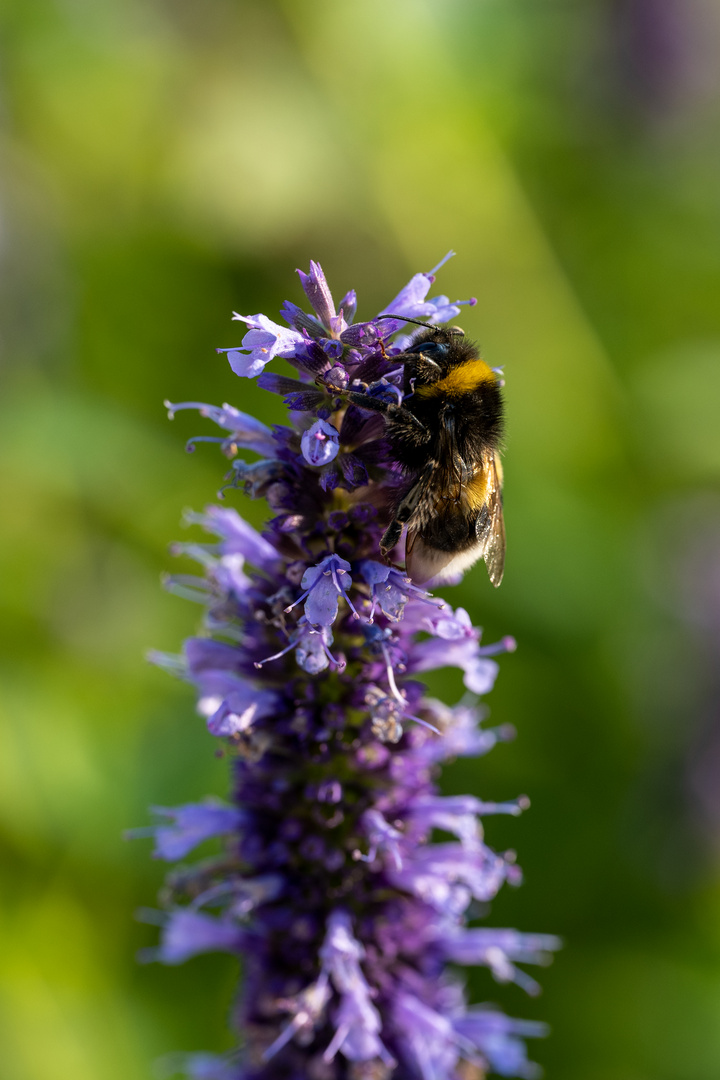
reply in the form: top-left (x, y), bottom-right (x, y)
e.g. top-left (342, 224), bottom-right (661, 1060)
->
top-left (0, 0), bottom-right (720, 1080)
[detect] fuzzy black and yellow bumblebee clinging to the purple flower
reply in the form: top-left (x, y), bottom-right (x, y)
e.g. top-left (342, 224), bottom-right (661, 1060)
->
top-left (334, 315), bottom-right (505, 585)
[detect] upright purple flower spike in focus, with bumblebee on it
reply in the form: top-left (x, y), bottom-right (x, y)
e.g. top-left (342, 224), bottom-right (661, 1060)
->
top-left (139, 257), bottom-right (558, 1080)
